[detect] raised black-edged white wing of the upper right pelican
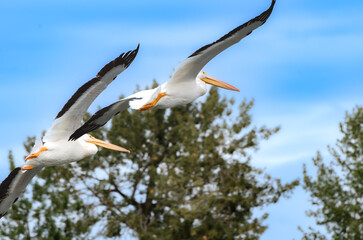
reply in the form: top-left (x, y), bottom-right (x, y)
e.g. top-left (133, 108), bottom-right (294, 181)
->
top-left (168, 0), bottom-right (276, 83)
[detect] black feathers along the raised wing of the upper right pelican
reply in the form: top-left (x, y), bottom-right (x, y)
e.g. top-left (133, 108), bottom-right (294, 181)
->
top-left (188, 0), bottom-right (276, 58)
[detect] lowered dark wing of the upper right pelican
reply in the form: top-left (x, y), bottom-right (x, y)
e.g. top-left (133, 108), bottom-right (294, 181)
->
top-left (69, 98), bottom-right (136, 141)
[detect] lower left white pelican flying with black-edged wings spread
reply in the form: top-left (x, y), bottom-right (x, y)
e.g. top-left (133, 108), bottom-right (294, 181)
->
top-left (0, 46), bottom-right (139, 218)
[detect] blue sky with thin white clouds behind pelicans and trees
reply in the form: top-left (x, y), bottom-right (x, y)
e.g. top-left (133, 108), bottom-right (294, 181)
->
top-left (0, 0), bottom-right (363, 240)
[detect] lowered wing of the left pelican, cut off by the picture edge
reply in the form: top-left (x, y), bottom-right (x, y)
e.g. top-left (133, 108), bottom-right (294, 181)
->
top-left (0, 167), bottom-right (42, 218)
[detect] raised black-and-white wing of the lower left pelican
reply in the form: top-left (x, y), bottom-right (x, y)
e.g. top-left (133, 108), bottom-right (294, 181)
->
top-left (43, 45), bottom-right (139, 142)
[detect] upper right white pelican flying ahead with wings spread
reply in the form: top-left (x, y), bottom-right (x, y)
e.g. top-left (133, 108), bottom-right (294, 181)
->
top-left (70, 0), bottom-right (276, 140)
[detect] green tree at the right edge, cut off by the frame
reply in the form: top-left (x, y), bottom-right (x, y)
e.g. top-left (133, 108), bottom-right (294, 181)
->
top-left (304, 107), bottom-right (363, 240)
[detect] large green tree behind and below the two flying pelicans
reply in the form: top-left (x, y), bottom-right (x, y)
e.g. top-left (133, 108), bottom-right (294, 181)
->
top-left (1, 85), bottom-right (298, 239)
